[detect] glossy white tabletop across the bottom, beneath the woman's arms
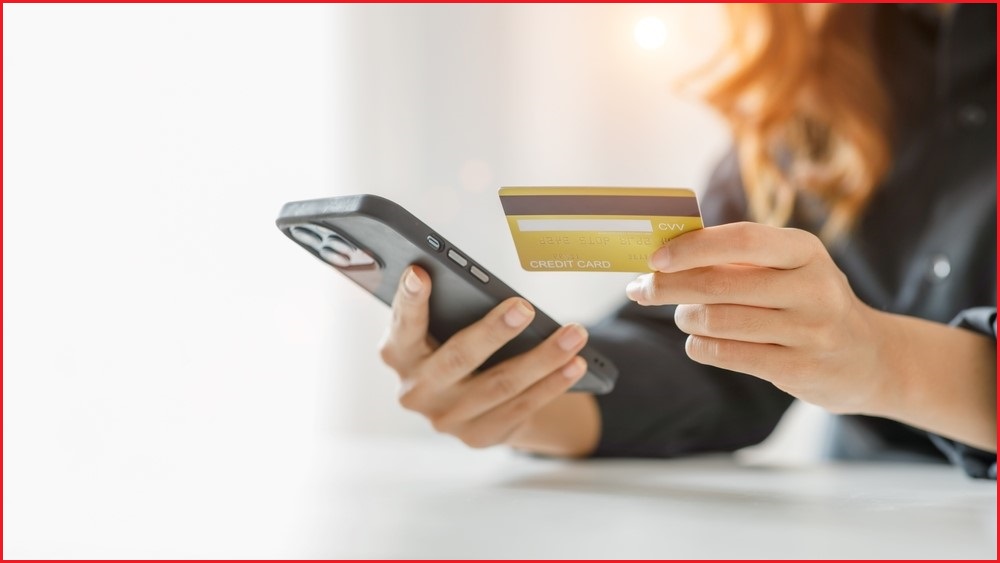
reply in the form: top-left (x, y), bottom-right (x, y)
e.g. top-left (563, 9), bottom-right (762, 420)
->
top-left (4, 437), bottom-right (997, 559)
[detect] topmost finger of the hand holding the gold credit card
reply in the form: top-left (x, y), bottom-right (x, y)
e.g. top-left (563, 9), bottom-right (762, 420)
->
top-left (649, 222), bottom-right (826, 272)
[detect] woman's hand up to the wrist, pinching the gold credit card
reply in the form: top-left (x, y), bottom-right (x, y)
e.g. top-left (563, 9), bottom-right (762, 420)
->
top-left (626, 223), bottom-right (887, 413)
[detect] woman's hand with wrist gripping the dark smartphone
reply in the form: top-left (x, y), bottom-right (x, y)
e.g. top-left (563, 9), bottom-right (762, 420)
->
top-left (381, 266), bottom-right (598, 455)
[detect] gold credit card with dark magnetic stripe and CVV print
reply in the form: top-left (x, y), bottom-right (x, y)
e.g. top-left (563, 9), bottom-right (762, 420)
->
top-left (500, 187), bottom-right (703, 272)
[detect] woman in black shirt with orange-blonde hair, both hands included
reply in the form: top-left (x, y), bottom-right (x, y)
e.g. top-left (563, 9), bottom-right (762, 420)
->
top-left (382, 5), bottom-right (997, 479)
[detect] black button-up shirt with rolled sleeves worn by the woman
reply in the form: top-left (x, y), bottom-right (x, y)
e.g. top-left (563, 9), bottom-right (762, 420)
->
top-left (590, 4), bottom-right (997, 478)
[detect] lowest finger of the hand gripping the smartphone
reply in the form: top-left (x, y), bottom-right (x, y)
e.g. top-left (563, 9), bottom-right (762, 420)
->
top-left (457, 356), bottom-right (587, 448)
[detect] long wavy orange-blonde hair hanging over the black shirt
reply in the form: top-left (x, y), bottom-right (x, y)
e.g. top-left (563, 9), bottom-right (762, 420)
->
top-left (705, 4), bottom-right (892, 241)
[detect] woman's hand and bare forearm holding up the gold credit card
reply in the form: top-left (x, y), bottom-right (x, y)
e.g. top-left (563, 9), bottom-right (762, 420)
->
top-left (626, 223), bottom-right (997, 451)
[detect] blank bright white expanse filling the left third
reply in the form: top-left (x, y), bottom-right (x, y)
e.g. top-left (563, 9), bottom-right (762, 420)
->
top-left (3, 4), bottom-right (340, 558)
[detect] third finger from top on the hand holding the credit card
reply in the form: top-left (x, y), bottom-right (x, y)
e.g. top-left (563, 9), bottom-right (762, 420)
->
top-left (674, 304), bottom-right (799, 346)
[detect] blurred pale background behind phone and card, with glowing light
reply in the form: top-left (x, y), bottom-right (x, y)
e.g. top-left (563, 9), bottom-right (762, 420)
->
top-left (3, 4), bottom-right (824, 558)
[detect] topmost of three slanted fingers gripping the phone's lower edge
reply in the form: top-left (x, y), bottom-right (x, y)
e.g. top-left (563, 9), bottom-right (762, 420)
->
top-left (420, 297), bottom-right (535, 387)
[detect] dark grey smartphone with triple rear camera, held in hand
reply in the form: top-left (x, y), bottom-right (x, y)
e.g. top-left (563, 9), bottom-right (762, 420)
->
top-left (276, 194), bottom-right (618, 394)
